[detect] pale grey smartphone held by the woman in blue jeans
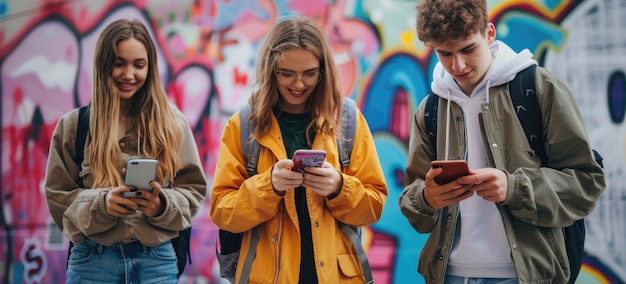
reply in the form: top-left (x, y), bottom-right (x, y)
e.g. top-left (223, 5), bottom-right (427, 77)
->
top-left (122, 159), bottom-right (159, 196)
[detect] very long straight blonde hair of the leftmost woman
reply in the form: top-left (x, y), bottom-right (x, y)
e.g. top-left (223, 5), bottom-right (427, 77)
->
top-left (88, 19), bottom-right (183, 188)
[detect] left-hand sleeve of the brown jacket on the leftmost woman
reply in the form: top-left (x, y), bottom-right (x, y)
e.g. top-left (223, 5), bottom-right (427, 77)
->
top-left (44, 110), bottom-right (117, 237)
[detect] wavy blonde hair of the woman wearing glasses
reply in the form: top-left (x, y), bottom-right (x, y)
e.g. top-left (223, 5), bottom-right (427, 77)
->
top-left (248, 17), bottom-right (343, 145)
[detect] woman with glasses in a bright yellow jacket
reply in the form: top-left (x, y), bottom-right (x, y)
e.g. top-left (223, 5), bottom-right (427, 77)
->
top-left (210, 17), bottom-right (387, 283)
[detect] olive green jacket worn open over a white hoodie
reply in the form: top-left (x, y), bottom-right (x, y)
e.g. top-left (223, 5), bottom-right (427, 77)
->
top-left (399, 67), bottom-right (605, 283)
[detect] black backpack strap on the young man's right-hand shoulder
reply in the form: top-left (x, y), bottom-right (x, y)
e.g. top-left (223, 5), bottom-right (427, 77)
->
top-left (509, 64), bottom-right (548, 166)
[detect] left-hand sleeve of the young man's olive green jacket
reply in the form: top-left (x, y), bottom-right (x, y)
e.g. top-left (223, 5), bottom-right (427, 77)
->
top-left (399, 97), bottom-right (440, 233)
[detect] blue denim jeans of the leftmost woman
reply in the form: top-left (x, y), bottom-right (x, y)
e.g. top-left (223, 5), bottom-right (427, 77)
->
top-left (66, 240), bottom-right (178, 284)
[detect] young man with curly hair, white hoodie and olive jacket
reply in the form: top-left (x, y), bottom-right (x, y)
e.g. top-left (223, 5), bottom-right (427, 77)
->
top-left (399, 0), bottom-right (605, 283)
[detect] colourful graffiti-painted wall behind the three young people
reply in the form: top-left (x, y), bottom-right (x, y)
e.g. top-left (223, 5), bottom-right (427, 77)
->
top-left (0, 0), bottom-right (626, 283)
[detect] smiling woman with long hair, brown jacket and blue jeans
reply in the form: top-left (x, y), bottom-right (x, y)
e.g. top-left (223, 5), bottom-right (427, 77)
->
top-left (45, 20), bottom-right (207, 283)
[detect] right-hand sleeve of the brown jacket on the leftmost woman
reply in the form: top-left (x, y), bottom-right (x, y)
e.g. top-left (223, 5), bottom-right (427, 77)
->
top-left (148, 109), bottom-right (207, 231)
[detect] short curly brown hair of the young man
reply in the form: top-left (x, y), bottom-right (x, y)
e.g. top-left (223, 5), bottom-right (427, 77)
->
top-left (416, 0), bottom-right (489, 44)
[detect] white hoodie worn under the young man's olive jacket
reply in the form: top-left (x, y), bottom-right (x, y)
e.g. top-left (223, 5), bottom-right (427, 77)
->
top-left (431, 41), bottom-right (537, 278)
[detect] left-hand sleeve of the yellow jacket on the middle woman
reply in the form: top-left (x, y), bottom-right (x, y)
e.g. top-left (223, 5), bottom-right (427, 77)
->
top-left (210, 112), bottom-right (282, 233)
